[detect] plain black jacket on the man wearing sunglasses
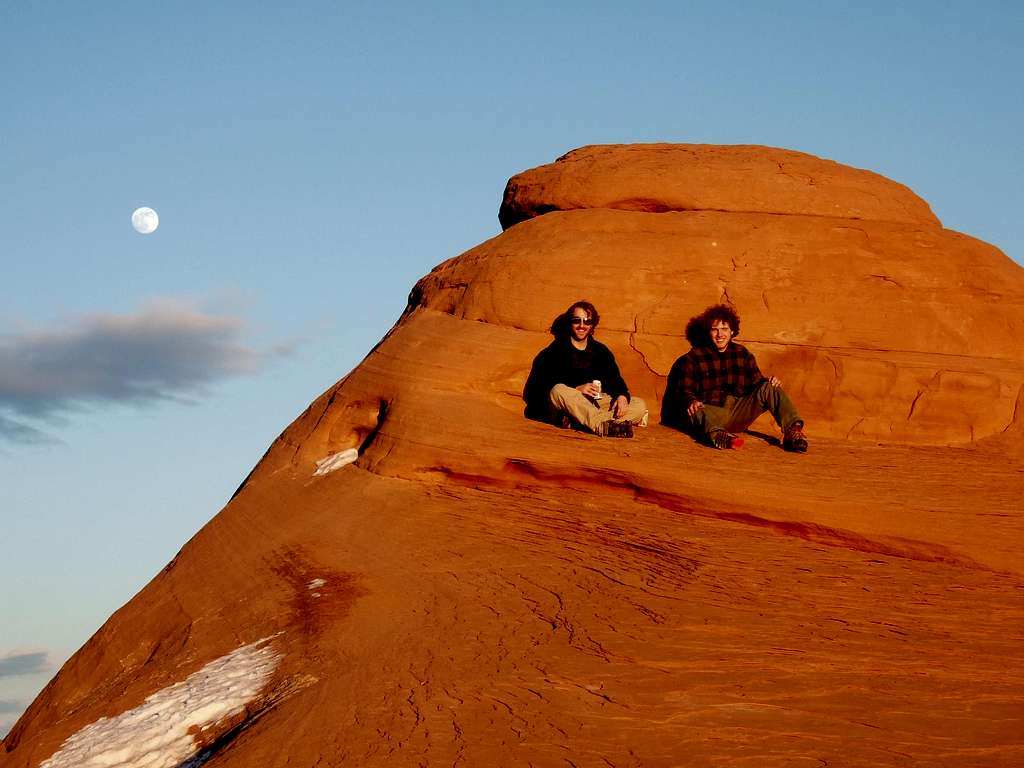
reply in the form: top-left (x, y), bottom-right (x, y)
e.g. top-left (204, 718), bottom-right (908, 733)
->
top-left (522, 338), bottom-right (630, 421)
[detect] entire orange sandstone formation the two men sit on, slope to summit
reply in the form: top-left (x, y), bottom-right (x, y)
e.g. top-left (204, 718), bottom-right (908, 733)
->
top-left (6, 145), bottom-right (1024, 767)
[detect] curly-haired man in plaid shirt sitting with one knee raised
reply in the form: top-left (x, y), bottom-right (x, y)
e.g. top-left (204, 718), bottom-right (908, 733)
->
top-left (662, 304), bottom-right (807, 453)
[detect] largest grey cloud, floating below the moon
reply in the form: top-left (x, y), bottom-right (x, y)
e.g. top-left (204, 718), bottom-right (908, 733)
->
top-left (0, 301), bottom-right (295, 443)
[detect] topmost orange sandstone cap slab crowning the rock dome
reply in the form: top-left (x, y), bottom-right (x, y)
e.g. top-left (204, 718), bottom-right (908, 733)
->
top-left (499, 144), bottom-right (940, 228)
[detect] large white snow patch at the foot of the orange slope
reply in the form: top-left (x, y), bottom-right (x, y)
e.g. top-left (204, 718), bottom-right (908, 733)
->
top-left (39, 638), bottom-right (281, 768)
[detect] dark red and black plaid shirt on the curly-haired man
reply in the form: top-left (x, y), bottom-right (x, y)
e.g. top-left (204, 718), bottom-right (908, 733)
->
top-left (662, 341), bottom-right (765, 428)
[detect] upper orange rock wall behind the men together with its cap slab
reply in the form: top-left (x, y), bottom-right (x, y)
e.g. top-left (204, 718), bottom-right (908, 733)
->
top-left (491, 145), bottom-right (1024, 444)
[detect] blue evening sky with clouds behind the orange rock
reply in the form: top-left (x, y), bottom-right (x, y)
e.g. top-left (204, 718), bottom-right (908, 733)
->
top-left (0, 0), bottom-right (1024, 734)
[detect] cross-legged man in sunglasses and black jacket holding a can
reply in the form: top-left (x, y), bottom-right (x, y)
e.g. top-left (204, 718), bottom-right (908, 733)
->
top-left (522, 301), bottom-right (647, 437)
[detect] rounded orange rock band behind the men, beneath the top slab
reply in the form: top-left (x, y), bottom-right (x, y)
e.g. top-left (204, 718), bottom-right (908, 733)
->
top-left (425, 210), bottom-right (1024, 444)
